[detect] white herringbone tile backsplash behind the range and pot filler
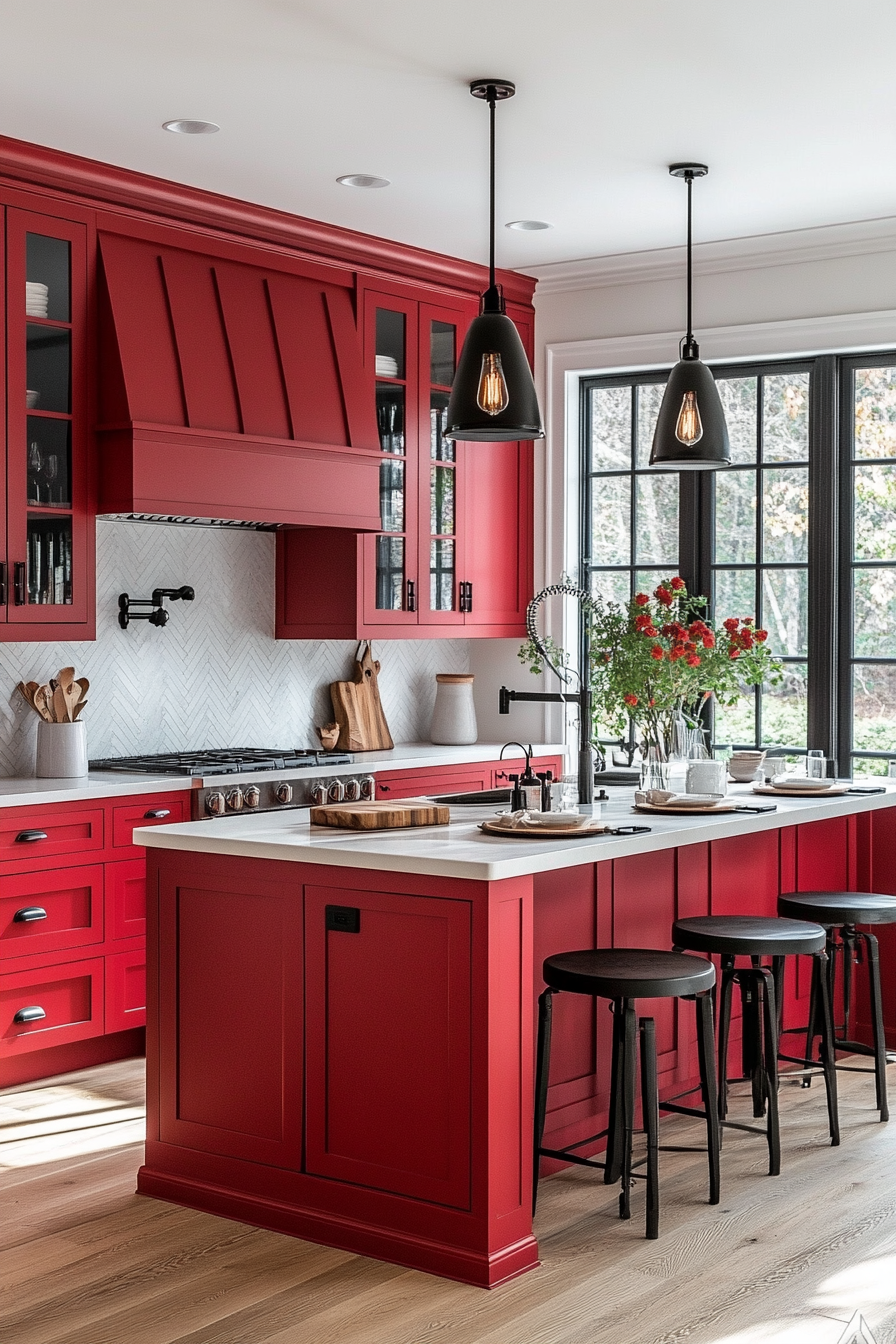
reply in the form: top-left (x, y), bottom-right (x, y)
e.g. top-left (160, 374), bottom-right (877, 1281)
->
top-left (0, 520), bottom-right (469, 775)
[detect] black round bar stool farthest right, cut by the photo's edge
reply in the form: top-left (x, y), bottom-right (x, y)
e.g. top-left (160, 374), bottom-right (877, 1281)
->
top-left (778, 891), bottom-right (896, 1120)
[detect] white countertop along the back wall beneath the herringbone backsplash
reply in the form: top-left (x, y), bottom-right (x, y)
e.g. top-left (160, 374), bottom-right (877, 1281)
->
top-left (0, 742), bottom-right (564, 808)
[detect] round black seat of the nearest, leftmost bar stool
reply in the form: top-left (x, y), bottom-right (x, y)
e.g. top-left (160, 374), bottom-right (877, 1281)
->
top-left (543, 937), bottom-right (714, 999)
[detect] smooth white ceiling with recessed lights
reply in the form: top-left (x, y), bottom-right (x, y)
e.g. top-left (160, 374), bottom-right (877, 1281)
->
top-left (0, 0), bottom-right (896, 269)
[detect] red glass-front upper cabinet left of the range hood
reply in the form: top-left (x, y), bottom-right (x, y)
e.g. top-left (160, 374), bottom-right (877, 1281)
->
top-left (5, 210), bottom-right (90, 626)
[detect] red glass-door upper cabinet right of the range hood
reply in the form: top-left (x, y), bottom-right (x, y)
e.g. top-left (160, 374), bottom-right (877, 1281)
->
top-left (277, 280), bottom-right (533, 638)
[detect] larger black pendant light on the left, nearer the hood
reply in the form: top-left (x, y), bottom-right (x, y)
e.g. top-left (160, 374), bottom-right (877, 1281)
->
top-left (445, 79), bottom-right (544, 444)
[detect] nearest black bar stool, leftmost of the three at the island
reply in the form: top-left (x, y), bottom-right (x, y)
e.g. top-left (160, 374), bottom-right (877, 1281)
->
top-left (532, 948), bottom-right (720, 1239)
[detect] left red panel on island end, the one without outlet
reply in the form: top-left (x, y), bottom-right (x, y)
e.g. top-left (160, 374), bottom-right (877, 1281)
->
top-left (159, 853), bottom-right (302, 1171)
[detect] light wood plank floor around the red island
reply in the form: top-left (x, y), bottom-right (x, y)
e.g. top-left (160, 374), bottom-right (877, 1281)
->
top-left (0, 1060), bottom-right (896, 1344)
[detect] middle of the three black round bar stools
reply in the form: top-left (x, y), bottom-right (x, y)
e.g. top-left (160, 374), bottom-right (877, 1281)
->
top-left (672, 915), bottom-right (840, 1176)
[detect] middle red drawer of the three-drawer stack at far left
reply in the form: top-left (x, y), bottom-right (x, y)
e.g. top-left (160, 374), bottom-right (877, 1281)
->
top-left (0, 864), bottom-right (103, 961)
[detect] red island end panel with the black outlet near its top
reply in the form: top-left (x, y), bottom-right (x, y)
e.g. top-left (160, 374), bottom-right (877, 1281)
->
top-left (305, 887), bottom-right (472, 1208)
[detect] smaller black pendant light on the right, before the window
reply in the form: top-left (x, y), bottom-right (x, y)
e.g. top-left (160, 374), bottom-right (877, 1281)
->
top-left (649, 164), bottom-right (731, 472)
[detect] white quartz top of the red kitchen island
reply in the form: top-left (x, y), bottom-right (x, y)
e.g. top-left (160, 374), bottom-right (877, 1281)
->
top-left (134, 785), bottom-right (896, 882)
